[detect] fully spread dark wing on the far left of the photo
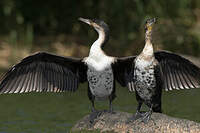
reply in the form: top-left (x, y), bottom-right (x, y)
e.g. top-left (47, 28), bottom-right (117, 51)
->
top-left (0, 52), bottom-right (87, 93)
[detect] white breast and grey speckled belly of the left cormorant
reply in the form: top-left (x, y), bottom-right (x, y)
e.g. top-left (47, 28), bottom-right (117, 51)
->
top-left (85, 57), bottom-right (114, 100)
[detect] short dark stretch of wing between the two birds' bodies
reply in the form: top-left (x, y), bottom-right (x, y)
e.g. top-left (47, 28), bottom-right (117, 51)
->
top-left (113, 56), bottom-right (135, 91)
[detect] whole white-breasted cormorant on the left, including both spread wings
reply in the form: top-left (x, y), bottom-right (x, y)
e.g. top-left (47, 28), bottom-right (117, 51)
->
top-left (0, 18), bottom-right (135, 115)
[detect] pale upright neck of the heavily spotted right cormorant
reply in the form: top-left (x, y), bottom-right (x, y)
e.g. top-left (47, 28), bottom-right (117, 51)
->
top-left (142, 30), bottom-right (154, 57)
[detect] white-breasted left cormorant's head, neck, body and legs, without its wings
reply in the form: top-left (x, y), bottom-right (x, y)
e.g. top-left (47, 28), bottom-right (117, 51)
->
top-left (80, 18), bottom-right (116, 112)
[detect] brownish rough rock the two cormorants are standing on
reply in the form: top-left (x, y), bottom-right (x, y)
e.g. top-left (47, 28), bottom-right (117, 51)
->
top-left (72, 111), bottom-right (200, 133)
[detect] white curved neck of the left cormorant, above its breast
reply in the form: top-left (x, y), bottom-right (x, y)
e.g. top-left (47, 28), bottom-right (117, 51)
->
top-left (89, 30), bottom-right (108, 56)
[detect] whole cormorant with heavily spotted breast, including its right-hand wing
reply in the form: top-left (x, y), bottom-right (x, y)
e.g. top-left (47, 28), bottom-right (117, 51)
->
top-left (129, 18), bottom-right (200, 122)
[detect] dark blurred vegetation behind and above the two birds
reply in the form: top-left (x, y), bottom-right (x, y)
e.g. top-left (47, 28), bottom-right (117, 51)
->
top-left (0, 0), bottom-right (200, 56)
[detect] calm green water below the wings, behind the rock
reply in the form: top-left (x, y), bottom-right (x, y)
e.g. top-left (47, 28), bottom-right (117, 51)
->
top-left (0, 84), bottom-right (200, 133)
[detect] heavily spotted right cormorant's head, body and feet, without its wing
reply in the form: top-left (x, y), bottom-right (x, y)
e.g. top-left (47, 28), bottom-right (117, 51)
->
top-left (126, 19), bottom-right (162, 122)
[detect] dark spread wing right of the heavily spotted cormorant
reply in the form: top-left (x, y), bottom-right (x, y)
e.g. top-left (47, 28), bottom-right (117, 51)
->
top-left (154, 51), bottom-right (200, 90)
